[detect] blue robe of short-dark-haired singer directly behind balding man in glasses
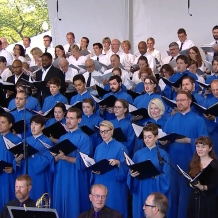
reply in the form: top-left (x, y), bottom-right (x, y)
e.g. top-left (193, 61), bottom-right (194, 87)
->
top-left (127, 146), bottom-right (172, 218)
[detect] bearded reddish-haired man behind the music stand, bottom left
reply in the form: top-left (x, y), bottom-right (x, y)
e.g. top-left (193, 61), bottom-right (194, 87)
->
top-left (0, 174), bottom-right (36, 218)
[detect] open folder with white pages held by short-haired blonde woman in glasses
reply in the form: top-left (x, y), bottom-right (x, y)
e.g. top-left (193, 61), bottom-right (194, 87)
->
top-left (79, 152), bottom-right (117, 174)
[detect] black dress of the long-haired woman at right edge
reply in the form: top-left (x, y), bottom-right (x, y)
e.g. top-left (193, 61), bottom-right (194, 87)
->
top-left (187, 160), bottom-right (218, 218)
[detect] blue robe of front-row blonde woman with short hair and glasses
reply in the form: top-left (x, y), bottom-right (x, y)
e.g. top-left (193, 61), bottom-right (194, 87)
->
top-left (92, 139), bottom-right (128, 218)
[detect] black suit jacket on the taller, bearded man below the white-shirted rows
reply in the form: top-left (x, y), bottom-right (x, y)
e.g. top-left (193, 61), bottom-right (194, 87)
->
top-left (36, 66), bottom-right (66, 102)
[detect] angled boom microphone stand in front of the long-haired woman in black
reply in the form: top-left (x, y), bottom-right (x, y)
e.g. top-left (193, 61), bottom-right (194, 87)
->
top-left (159, 152), bottom-right (203, 218)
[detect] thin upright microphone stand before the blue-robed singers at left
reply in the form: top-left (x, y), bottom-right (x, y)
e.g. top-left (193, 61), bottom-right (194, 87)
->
top-left (22, 85), bottom-right (29, 175)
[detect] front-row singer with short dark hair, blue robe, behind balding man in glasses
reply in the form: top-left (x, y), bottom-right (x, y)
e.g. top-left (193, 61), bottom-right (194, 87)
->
top-left (127, 123), bottom-right (171, 218)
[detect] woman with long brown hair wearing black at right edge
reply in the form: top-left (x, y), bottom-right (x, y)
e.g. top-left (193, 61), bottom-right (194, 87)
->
top-left (187, 136), bottom-right (218, 218)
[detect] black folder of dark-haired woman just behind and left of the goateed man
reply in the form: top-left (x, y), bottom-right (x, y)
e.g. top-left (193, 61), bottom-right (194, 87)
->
top-left (42, 122), bottom-right (67, 139)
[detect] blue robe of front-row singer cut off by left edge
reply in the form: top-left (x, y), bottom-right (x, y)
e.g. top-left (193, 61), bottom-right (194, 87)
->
top-left (0, 132), bottom-right (21, 210)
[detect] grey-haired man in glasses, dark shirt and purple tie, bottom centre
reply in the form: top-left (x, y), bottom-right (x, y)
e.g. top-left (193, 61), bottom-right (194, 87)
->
top-left (78, 184), bottom-right (123, 218)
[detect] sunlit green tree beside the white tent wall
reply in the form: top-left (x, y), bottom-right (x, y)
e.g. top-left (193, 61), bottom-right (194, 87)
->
top-left (0, 0), bottom-right (49, 43)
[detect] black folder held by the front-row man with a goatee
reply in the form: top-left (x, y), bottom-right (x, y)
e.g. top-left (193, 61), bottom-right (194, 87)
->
top-left (49, 139), bottom-right (77, 155)
